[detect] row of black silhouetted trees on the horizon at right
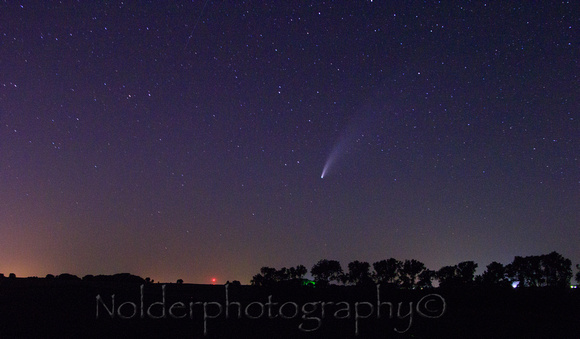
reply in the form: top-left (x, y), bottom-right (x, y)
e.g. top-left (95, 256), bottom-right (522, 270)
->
top-left (250, 252), bottom-right (580, 289)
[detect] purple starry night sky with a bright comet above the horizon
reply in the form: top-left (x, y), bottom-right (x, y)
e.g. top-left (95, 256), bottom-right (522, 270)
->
top-left (0, 0), bottom-right (580, 283)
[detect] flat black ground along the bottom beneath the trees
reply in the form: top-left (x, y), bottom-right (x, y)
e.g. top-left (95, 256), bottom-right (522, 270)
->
top-left (0, 278), bottom-right (580, 338)
